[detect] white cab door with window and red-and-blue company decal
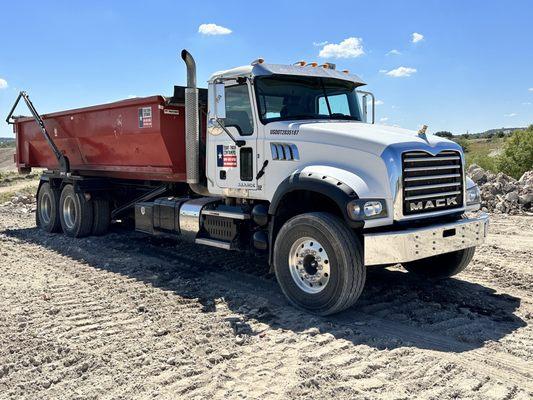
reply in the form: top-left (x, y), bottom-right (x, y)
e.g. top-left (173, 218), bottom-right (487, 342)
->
top-left (213, 82), bottom-right (258, 191)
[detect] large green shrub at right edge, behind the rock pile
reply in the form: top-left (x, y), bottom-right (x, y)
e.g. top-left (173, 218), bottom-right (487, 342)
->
top-left (497, 125), bottom-right (533, 179)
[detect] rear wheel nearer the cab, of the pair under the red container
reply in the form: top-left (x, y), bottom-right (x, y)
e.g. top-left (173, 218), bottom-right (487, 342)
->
top-left (59, 185), bottom-right (93, 237)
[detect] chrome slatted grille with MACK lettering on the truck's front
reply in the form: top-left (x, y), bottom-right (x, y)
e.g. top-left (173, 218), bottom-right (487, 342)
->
top-left (402, 150), bottom-right (463, 215)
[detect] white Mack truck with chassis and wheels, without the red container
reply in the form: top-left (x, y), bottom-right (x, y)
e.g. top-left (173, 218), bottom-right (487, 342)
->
top-left (11, 50), bottom-right (488, 315)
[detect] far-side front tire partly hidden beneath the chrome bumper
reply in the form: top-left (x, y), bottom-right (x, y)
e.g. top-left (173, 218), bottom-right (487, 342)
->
top-left (402, 247), bottom-right (476, 279)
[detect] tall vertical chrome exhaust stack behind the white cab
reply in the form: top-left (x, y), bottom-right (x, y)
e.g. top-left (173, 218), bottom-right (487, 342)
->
top-left (181, 49), bottom-right (209, 196)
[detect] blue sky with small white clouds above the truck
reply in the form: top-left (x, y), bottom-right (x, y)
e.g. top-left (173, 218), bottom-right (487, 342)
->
top-left (0, 0), bottom-right (533, 136)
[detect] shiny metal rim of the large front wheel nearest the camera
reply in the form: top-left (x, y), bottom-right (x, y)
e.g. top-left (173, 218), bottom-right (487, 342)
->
top-left (289, 237), bottom-right (331, 294)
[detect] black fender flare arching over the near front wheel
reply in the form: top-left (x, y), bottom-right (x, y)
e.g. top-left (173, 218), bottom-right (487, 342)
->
top-left (268, 172), bottom-right (364, 228)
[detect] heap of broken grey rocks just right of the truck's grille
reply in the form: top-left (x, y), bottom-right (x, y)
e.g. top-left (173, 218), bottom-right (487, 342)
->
top-left (467, 164), bottom-right (533, 214)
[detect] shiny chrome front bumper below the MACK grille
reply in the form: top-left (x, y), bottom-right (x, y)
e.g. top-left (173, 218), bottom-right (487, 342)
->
top-left (364, 213), bottom-right (489, 265)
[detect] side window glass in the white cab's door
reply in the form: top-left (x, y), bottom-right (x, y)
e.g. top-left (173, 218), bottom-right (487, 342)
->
top-left (224, 84), bottom-right (254, 136)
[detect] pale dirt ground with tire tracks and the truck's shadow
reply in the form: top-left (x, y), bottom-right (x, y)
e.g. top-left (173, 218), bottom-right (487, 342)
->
top-left (0, 207), bottom-right (533, 400)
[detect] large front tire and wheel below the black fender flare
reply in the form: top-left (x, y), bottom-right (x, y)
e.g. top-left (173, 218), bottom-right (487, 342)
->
top-left (274, 212), bottom-right (366, 315)
